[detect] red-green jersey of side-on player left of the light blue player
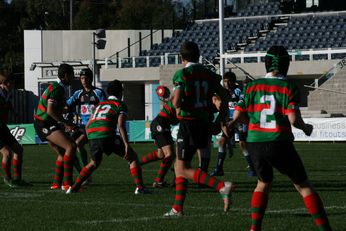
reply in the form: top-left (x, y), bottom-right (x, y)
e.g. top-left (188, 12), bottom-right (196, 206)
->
top-left (34, 82), bottom-right (66, 121)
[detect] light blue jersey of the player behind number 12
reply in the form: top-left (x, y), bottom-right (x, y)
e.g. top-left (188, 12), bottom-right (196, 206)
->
top-left (66, 87), bottom-right (107, 125)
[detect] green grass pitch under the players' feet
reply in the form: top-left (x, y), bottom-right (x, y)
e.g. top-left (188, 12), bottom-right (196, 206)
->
top-left (0, 143), bottom-right (346, 231)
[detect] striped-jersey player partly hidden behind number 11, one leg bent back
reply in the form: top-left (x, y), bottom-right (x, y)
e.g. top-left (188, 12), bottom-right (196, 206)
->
top-left (140, 85), bottom-right (178, 188)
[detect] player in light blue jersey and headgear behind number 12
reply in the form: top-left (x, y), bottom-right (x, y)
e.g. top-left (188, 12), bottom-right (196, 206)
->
top-left (66, 68), bottom-right (106, 177)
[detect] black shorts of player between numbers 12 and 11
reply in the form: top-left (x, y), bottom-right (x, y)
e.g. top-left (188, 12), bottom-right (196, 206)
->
top-left (150, 117), bottom-right (174, 148)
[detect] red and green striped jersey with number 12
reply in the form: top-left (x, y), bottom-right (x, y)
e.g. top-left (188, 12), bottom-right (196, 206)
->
top-left (86, 96), bottom-right (127, 140)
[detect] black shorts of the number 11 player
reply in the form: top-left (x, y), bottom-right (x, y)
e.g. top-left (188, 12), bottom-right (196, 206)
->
top-left (177, 120), bottom-right (211, 162)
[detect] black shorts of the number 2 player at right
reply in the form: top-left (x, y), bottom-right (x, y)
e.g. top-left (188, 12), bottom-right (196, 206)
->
top-left (247, 141), bottom-right (307, 184)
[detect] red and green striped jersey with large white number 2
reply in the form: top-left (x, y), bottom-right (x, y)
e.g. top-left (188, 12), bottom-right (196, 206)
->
top-left (236, 77), bottom-right (300, 142)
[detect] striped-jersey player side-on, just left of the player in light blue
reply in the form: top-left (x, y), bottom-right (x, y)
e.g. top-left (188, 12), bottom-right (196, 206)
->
top-left (34, 64), bottom-right (76, 191)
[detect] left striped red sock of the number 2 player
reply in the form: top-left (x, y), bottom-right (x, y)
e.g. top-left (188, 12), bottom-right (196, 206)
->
top-left (250, 192), bottom-right (268, 231)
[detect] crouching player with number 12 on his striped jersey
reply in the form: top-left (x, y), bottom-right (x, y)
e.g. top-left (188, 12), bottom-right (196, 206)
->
top-left (66, 80), bottom-right (148, 194)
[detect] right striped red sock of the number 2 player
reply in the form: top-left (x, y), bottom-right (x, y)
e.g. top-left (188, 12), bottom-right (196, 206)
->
top-left (303, 193), bottom-right (332, 231)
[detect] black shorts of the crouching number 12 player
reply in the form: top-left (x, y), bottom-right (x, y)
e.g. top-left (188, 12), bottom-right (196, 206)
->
top-left (89, 136), bottom-right (125, 162)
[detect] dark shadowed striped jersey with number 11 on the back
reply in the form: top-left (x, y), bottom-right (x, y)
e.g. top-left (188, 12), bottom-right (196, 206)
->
top-left (173, 64), bottom-right (221, 121)
